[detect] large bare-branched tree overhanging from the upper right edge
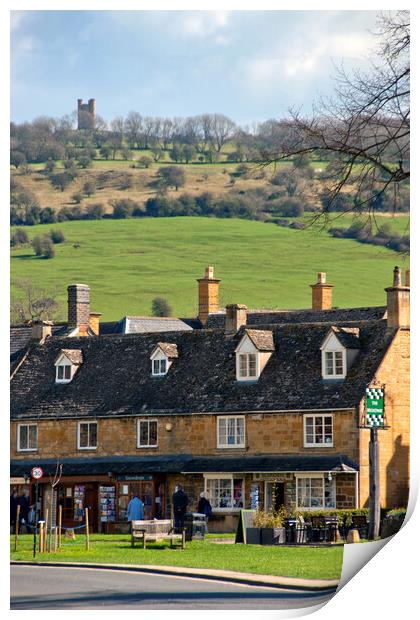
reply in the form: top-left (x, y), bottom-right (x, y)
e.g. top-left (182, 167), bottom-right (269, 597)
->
top-left (263, 11), bottom-right (410, 215)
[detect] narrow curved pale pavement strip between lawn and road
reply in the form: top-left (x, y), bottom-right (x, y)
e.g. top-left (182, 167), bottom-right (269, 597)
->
top-left (11, 561), bottom-right (339, 592)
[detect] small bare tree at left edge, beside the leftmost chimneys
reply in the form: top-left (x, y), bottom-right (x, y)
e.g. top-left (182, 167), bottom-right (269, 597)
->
top-left (10, 280), bottom-right (60, 323)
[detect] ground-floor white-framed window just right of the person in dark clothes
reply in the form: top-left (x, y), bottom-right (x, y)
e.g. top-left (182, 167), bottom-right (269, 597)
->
top-left (204, 474), bottom-right (244, 512)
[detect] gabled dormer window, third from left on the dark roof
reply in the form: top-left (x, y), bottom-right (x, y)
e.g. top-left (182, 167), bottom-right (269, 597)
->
top-left (235, 329), bottom-right (274, 381)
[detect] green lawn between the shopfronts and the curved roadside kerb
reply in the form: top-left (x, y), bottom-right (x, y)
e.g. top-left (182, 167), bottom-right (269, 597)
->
top-left (10, 535), bottom-right (344, 579)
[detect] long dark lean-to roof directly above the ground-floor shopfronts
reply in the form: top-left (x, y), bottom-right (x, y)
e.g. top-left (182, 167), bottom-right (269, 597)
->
top-left (10, 454), bottom-right (358, 476)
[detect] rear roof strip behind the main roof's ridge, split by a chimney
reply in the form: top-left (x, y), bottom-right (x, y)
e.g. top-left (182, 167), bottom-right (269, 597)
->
top-left (206, 306), bottom-right (386, 328)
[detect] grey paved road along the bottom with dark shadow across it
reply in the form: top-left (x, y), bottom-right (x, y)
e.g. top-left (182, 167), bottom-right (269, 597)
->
top-left (10, 566), bottom-right (331, 609)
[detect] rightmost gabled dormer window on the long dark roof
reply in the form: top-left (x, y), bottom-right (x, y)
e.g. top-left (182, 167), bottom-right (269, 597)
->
top-left (320, 327), bottom-right (360, 380)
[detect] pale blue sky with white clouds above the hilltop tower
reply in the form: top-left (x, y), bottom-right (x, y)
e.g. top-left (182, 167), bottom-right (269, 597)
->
top-left (11, 11), bottom-right (376, 124)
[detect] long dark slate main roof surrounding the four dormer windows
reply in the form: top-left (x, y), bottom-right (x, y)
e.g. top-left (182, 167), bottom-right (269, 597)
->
top-left (11, 321), bottom-right (396, 419)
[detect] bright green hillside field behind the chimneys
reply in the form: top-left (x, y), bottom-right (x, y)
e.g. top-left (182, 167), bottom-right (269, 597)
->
top-left (11, 217), bottom-right (409, 320)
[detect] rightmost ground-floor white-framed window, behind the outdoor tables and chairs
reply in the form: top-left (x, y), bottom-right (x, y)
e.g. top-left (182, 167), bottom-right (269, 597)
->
top-left (296, 474), bottom-right (335, 510)
